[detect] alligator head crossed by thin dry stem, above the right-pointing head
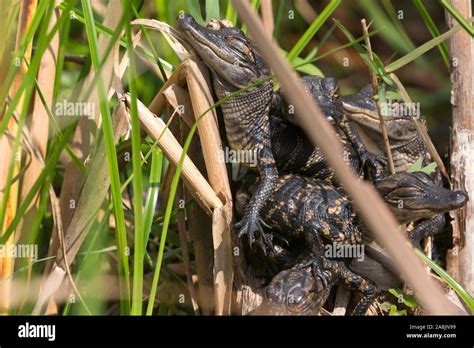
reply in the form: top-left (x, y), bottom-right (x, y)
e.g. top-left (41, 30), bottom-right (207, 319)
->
top-left (341, 86), bottom-right (426, 172)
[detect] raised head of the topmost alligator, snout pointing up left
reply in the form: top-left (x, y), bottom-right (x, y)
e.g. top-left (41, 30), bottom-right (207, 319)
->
top-left (177, 15), bottom-right (270, 90)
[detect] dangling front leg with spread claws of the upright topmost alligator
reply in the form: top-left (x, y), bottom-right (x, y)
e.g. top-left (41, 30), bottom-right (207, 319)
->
top-left (236, 146), bottom-right (278, 254)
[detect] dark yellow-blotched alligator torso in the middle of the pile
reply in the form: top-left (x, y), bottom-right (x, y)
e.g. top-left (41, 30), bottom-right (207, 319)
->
top-left (236, 174), bottom-right (362, 254)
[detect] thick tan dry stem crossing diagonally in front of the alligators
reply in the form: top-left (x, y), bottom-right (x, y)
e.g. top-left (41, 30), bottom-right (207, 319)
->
top-left (232, 0), bottom-right (456, 315)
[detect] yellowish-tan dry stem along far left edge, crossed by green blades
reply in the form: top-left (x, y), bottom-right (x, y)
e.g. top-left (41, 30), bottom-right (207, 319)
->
top-left (0, 0), bottom-right (37, 315)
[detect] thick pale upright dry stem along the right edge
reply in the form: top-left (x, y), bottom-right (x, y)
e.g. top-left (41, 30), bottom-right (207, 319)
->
top-left (447, 0), bottom-right (474, 293)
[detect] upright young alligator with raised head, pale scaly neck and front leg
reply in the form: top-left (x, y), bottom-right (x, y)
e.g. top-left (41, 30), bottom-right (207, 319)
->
top-left (177, 15), bottom-right (278, 251)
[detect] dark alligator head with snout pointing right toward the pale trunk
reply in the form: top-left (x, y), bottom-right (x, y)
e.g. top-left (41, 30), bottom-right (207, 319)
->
top-left (376, 172), bottom-right (468, 224)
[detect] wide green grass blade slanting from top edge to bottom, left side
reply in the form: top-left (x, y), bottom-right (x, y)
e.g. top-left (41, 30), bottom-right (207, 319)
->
top-left (82, 0), bottom-right (130, 314)
